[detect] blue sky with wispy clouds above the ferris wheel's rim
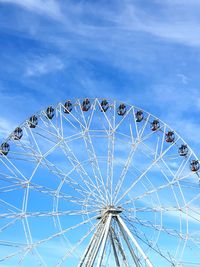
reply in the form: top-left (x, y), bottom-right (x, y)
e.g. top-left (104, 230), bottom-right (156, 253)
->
top-left (0, 0), bottom-right (200, 266)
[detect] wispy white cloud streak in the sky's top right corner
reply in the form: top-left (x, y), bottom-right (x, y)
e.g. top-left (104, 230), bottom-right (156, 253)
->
top-left (105, 0), bottom-right (200, 46)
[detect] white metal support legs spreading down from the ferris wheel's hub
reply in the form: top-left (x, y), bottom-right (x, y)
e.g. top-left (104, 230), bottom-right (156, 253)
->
top-left (78, 206), bottom-right (153, 267)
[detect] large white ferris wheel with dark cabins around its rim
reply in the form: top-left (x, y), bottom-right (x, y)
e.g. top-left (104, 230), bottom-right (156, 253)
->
top-left (0, 98), bottom-right (200, 267)
